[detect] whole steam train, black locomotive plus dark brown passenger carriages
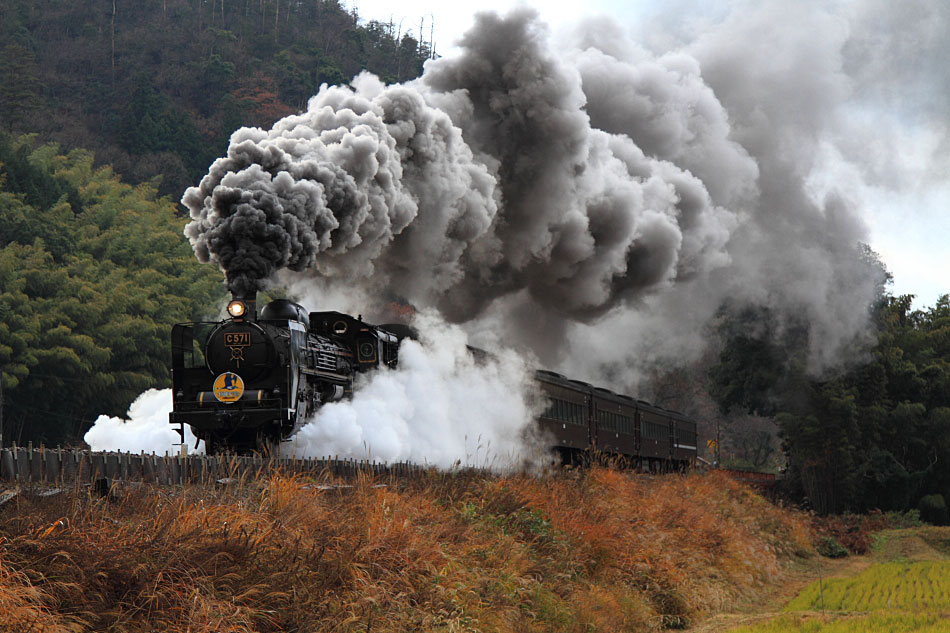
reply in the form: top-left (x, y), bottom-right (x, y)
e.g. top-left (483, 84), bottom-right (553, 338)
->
top-left (169, 298), bottom-right (697, 472)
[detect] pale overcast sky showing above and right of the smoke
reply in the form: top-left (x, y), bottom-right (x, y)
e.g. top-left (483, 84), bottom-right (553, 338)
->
top-left (345, 0), bottom-right (950, 307)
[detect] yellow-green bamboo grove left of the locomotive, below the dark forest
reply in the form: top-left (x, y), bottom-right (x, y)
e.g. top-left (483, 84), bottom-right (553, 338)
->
top-left (0, 133), bottom-right (224, 444)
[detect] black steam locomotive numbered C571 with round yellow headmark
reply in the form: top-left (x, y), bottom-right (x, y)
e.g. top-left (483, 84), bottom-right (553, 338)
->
top-left (169, 298), bottom-right (405, 454)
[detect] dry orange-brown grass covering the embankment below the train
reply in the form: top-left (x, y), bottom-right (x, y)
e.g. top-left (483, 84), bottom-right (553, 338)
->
top-left (0, 469), bottom-right (811, 633)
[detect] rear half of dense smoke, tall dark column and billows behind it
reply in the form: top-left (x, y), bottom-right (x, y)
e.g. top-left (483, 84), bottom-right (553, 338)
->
top-left (421, 11), bottom-right (735, 319)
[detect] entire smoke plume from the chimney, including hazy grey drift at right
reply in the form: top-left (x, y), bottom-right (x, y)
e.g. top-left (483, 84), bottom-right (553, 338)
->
top-left (183, 3), bottom-right (944, 380)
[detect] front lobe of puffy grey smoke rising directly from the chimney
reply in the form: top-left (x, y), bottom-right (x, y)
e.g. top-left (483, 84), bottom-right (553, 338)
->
top-left (182, 82), bottom-right (496, 293)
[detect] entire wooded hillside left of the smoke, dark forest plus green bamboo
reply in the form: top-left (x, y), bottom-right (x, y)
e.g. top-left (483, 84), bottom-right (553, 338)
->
top-left (0, 0), bottom-right (432, 444)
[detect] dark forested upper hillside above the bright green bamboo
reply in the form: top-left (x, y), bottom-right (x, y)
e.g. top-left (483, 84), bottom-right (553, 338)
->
top-left (0, 0), bottom-right (432, 199)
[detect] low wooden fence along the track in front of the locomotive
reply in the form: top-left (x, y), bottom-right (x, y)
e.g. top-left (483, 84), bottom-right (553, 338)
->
top-left (0, 447), bottom-right (424, 485)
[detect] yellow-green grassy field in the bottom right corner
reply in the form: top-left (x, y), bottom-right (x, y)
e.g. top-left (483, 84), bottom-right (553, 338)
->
top-left (730, 527), bottom-right (950, 633)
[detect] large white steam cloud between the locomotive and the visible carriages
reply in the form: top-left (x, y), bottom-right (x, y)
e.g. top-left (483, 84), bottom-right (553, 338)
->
top-left (282, 314), bottom-right (544, 470)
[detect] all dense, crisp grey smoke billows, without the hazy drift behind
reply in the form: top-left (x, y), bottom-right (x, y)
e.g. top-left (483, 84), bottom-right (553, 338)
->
top-left (183, 11), bottom-right (735, 321)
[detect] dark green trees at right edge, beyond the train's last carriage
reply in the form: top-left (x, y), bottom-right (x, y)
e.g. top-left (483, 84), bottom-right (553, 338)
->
top-left (709, 291), bottom-right (950, 523)
